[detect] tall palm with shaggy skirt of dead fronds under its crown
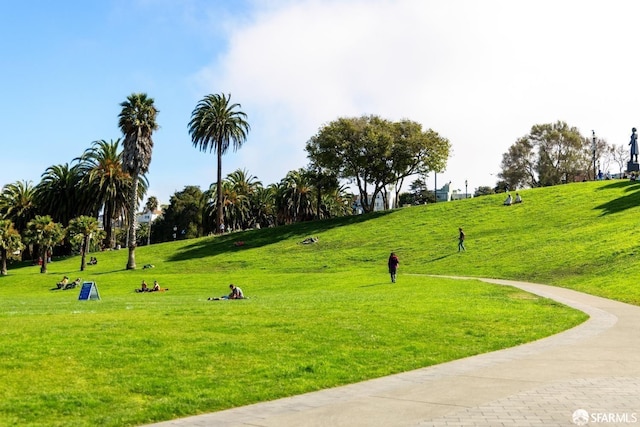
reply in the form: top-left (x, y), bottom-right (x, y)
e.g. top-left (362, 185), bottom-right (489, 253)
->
top-left (118, 93), bottom-right (158, 270)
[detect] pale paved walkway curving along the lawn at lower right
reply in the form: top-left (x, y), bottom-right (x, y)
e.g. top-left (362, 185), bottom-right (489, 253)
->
top-left (146, 279), bottom-right (640, 427)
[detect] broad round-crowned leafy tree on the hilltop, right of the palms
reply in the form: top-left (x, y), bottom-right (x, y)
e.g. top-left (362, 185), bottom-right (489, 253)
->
top-left (306, 116), bottom-right (450, 212)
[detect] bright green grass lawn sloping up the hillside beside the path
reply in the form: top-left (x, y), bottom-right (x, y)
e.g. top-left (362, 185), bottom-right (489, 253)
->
top-left (0, 181), bottom-right (640, 426)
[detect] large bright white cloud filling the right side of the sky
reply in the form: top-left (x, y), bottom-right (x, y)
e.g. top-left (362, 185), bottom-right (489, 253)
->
top-left (192, 0), bottom-right (639, 194)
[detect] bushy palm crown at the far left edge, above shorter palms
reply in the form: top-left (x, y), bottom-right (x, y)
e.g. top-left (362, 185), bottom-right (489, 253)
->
top-left (0, 181), bottom-right (37, 233)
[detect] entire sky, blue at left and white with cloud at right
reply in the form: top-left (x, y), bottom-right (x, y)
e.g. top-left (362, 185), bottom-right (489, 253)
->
top-left (0, 0), bottom-right (640, 203)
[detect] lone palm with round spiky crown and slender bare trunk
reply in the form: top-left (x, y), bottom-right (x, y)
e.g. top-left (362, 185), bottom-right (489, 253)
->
top-left (189, 94), bottom-right (250, 233)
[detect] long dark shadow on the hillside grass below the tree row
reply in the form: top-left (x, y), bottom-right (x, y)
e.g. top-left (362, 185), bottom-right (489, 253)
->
top-left (169, 211), bottom-right (393, 261)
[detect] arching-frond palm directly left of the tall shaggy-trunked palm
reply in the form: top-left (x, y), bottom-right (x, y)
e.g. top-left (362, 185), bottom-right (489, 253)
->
top-left (74, 138), bottom-right (132, 248)
